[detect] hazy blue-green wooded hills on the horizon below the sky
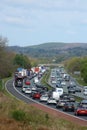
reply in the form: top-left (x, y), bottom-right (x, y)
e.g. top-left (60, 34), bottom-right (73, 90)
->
top-left (7, 42), bottom-right (87, 59)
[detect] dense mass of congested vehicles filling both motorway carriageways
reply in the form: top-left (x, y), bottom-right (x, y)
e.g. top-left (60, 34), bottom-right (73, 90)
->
top-left (14, 67), bottom-right (87, 120)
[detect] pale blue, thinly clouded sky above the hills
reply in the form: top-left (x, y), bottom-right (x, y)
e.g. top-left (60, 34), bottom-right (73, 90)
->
top-left (0, 0), bottom-right (87, 46)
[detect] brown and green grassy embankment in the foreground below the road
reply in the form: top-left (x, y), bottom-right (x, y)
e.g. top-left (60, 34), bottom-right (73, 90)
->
top-left (0, 76), bottom-right (87, 130)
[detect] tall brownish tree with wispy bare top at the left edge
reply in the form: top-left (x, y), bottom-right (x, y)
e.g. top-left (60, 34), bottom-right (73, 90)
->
top-left (0, 36), bottom-right (14, 78)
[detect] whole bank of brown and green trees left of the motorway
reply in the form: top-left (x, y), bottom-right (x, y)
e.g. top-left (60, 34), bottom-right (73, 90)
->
top-left (0, 36), bottom-right (31, 79)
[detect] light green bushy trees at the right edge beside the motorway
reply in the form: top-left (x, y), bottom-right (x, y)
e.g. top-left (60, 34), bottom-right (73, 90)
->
top-left (65, 56), bottom-right (87, 83)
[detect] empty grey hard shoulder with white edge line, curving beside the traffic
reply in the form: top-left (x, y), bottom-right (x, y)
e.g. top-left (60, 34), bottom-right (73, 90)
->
top-left (5, 79), bottom-right (87, 121)
